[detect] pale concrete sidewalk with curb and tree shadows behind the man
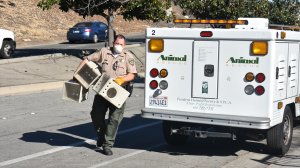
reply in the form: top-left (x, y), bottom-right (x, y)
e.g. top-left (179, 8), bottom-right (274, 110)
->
top-left (0, 44), bottom-right (145, 95)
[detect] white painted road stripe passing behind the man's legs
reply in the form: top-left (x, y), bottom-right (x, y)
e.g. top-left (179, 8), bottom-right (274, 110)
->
top-left (0, 121), bottom-right (161, 167)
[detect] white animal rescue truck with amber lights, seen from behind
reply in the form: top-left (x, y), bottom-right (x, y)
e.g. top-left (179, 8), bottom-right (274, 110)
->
top-left (142, 18), bottom-right (300, 155)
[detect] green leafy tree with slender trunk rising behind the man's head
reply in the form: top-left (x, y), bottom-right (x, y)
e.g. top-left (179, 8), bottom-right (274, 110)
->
top-left (38, 0), bottom-right (171, 46)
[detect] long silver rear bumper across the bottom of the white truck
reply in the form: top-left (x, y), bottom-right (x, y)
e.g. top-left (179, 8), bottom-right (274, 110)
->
top-left (142, 108), bottom-right (270, 129)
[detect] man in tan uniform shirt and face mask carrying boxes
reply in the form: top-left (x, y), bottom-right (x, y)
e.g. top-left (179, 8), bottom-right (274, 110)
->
top-left (81, 35), bottom-right (137, 155)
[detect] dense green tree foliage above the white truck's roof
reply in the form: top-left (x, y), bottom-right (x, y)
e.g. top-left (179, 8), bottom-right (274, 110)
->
top-left (174, 0), bottom-right (300, 25)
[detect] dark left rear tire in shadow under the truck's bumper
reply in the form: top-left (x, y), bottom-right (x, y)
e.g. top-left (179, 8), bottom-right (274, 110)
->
top-left (162, 121), bottom-right (189, 146)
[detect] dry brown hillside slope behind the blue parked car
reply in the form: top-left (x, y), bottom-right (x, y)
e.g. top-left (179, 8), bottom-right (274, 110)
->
top-left (0, 0), bottom-right (151, 44)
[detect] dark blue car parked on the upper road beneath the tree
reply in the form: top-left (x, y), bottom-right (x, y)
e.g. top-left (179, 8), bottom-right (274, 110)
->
top-left (67, 22), bottom-right (108, 43)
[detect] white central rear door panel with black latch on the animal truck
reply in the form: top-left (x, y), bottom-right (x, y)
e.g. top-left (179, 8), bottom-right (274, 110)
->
top-left (192, 41), bottom-right (219, 99)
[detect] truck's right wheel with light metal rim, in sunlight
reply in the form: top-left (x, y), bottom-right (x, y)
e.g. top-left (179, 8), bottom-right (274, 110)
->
top-left (267, 106), bottom-right (293, 156)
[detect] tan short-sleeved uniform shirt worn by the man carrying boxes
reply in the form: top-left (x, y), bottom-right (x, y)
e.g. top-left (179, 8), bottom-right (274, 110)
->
top-left (86, 48), bottom-right (137, 78)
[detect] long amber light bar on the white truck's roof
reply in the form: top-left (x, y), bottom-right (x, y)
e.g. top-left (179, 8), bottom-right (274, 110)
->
top-left (173, 19), bottom-right (248, 25)
